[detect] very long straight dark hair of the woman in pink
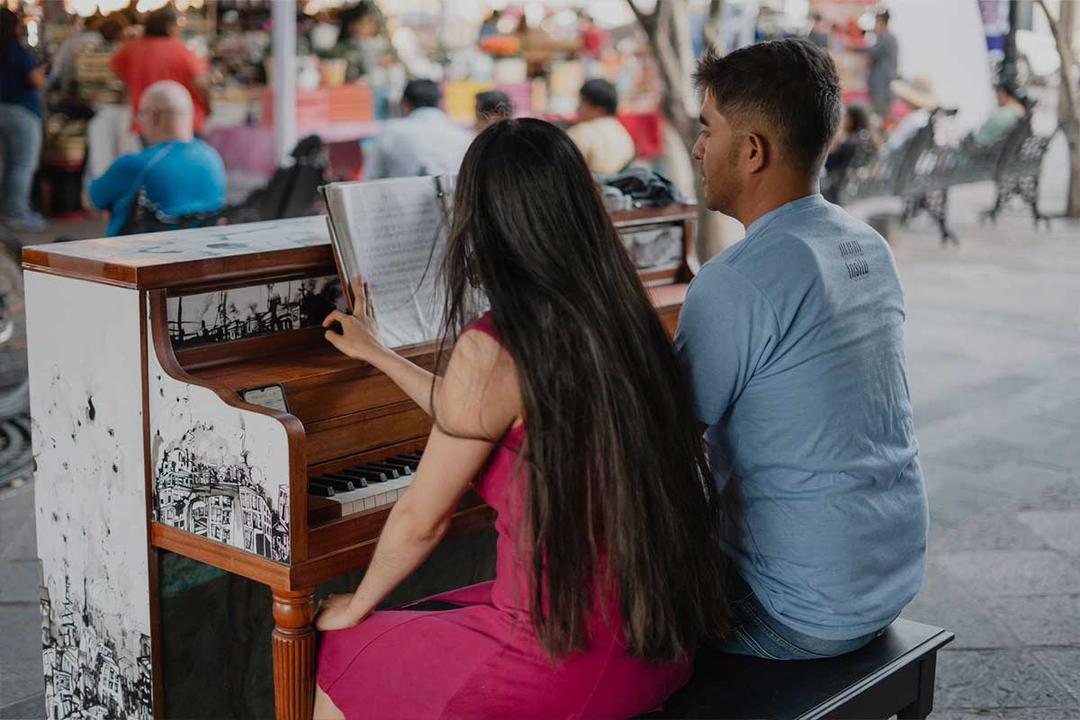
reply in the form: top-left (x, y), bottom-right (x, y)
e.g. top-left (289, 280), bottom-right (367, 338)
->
top-left (436, 119), bottom-right (728, 661)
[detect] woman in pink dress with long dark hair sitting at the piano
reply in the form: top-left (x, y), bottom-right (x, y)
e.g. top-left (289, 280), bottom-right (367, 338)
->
top-left (315, 120), bottom-right (728, 718)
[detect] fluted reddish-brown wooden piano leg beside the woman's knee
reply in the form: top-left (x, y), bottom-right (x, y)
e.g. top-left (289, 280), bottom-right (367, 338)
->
top-left (273, 589), bottom-right (315, 720)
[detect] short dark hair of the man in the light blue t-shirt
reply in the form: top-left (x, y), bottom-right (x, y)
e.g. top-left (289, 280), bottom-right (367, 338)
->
top-left (693, 38), bottom-right (841, 173)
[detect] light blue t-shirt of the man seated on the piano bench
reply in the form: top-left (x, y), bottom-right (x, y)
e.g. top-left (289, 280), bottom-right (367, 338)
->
top-left (675, 194), bottom-right (928, 640)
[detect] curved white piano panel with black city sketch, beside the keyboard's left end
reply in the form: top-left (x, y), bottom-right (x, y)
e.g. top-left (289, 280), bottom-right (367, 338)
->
top-left (147, 303), bottom-right (293, 562)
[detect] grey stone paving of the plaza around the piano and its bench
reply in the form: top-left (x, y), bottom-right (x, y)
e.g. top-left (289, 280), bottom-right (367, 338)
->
top-left (0, 186), bottom-right (1080, 720)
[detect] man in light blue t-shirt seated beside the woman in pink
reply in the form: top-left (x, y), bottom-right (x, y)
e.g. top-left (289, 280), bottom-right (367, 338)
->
top-left (675, 40), bottom-right (928, 660)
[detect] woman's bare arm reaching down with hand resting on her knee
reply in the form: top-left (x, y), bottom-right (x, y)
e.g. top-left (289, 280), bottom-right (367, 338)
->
top-left (316, 330), bottom-right (522, 630)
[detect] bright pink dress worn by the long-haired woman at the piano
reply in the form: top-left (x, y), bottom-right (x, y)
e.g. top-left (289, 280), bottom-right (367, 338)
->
top-left (318, 315), bottom-right (691, 720)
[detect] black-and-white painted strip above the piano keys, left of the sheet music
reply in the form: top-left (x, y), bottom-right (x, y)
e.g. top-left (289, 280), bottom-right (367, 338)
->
top-left (167, 275), bottom-right (345, 348)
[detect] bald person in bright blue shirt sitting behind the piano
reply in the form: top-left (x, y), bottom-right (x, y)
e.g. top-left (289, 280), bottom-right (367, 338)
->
top-left (86, 80), bottom-right (226, 236)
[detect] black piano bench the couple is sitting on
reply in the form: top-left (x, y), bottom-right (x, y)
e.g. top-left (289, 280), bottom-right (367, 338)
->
top-left (646, 620), bottom-right (954, 720)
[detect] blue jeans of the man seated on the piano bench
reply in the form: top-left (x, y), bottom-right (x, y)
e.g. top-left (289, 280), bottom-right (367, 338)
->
top-left (717, 576), bottom-right (885, 660)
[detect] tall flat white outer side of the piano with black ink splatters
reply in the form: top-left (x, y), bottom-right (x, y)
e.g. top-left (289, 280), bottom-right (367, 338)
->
top-left (25, 272), bottom-right (153, 718)
